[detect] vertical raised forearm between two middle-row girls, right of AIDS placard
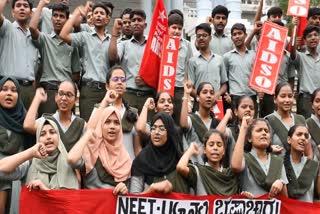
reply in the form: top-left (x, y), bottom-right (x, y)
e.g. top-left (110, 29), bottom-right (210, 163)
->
top-left (180, 81), bottom-right (193, 129)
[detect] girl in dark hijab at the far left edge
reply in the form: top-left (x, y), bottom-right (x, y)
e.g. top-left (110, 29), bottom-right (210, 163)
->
top-left (0, 77), bottom-right (26, 213)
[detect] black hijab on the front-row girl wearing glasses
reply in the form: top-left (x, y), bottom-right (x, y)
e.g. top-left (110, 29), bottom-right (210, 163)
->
top-left (131, 112), bottom-right (181, 180)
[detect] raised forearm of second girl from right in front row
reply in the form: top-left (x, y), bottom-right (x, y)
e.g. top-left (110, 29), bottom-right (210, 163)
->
top-left (231, 116), bottom-right (250, 172)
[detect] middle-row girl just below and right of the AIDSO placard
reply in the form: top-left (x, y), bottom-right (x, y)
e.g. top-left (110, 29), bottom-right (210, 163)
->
top-left (266, 82), bottom-right (312, 157)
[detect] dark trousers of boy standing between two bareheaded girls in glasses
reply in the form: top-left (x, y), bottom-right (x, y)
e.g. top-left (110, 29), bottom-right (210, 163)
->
top-left (79, 86), bottom-right (106, 121)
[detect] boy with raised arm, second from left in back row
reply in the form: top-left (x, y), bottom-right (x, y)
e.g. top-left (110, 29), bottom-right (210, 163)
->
top-left (30, 0), bottom-right (80, 115)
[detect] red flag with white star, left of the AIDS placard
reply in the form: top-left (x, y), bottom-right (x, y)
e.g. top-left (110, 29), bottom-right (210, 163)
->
top-left (139, 0), bottom-right (168, 89)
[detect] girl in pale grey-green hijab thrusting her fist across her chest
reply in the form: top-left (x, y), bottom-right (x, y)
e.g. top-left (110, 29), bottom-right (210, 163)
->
top-left (0, 119), bottom-right (79, 213)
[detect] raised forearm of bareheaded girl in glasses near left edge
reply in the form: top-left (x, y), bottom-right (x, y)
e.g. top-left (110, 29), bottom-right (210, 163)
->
top-left (23, 88), bottom-right (47, 134)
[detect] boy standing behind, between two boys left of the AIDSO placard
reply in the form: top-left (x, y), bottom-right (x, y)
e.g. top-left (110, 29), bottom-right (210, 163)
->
top-left (210, 5), bottom-right (234, 56)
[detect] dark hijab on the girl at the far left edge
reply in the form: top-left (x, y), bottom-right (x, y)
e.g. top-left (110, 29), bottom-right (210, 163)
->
top-left (0, 77), bottom-right (26, 133)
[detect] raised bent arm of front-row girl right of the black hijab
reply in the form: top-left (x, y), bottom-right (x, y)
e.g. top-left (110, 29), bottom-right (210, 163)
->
top-left (177, 143), bottom-right (199, 177)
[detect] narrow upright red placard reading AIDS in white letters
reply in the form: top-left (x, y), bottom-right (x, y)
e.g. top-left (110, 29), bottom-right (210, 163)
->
top-left (158, 35), bottom-right (180, 96)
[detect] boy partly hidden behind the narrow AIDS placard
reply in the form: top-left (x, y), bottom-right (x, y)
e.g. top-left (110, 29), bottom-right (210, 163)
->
top-left (168, 13), bottom-right (193, 124)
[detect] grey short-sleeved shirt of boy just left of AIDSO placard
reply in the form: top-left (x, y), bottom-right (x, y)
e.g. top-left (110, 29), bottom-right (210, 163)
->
top-left (223, 49), bottom-right (256, 96)
